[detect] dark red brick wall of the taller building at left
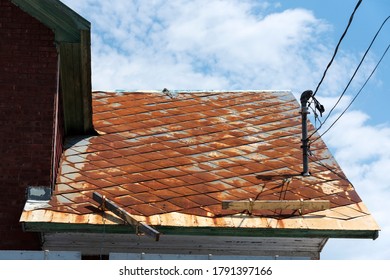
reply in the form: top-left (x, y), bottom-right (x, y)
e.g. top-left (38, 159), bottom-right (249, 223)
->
top-left (0, 0), bottom-right (62, 250)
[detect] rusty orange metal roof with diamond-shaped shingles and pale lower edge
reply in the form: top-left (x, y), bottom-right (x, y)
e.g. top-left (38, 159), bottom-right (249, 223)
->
top-left (21, 91), bottom-right (379, 238)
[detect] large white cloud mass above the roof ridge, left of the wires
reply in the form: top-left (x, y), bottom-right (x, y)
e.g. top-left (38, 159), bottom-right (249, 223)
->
top-left (61, 0), bottom-right (328, 90)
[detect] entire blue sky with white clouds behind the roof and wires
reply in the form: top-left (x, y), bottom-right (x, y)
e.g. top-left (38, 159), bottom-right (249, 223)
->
top-left (63, 0), bottom-right (390, 259)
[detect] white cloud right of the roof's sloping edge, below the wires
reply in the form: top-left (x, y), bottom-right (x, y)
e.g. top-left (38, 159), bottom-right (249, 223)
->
top-left (324, 108), bottom-right (390, 259)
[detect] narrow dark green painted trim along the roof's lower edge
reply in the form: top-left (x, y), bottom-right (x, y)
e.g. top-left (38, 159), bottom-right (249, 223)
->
top-left (23, 222), bottom-right (379, 240)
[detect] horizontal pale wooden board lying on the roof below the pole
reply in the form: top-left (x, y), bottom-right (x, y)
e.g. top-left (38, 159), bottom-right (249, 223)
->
top-left (222, 200), bottom-right (330, 213)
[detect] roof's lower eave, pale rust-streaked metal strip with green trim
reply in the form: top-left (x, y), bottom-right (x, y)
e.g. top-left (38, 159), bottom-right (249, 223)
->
top-left (20, 203), bottom-right (380, 239)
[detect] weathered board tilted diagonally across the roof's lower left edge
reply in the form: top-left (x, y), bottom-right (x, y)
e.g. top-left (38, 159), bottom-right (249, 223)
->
top-left (92, 192), bottom-right (160, 241)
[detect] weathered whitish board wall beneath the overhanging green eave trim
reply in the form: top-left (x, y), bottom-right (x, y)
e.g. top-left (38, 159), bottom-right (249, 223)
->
top-left (42, 232), bottom-right (327, 259)
